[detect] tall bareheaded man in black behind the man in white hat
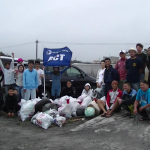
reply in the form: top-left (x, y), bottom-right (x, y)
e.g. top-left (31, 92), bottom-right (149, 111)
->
top-left (136, 43), bottom-right (147, 80)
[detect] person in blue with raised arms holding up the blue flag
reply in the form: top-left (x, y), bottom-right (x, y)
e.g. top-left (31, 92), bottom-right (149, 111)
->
top-left (45, 66), bottom-right (70, 99)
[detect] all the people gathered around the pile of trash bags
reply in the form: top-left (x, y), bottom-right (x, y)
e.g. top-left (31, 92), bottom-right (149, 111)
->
top-left (0, 43), bottom-right (150, 124)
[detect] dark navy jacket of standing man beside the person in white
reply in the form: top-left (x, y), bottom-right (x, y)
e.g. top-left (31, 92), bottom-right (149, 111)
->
top-left (104, 65), bottom-right (120, 84)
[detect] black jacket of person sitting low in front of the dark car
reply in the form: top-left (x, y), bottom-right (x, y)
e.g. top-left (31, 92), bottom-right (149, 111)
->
top-left (61, 86), bottom-right (76, 98)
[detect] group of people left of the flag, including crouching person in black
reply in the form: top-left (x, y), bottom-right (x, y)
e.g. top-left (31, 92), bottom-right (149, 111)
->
top-left (0, 53), bottom-right (44, 116)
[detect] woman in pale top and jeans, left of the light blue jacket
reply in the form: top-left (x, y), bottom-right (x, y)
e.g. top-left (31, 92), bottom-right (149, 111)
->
top-left (14, 65), bottom-right (24, 98)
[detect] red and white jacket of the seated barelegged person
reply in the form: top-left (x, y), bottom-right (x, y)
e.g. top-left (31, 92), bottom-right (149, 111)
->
top-left (106, 89), bottom-right (123, 110)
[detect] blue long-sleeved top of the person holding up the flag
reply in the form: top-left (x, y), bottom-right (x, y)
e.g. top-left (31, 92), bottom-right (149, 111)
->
top-left (45, 67), bottom-right (69, 89)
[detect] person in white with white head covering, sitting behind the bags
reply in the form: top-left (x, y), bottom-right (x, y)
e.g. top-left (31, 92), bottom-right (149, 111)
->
top-left (78, 83), bottom-right (93, 108)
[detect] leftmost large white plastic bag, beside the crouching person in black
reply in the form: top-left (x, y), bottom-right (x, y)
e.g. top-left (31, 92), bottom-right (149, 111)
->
top-left (19, 98), bottom-right (41, 121)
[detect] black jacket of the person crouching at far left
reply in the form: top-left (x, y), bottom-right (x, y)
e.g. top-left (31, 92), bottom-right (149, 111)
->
top-left (5, 94), bottom-right (18, 111)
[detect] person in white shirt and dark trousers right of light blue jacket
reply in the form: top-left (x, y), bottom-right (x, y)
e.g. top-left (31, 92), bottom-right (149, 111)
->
top-left (35, 60), bottom-right (44, 98)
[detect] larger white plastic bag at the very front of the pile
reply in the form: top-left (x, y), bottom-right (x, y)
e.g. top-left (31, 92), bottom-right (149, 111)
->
top-left (31, 112), bottom-right (54, 129)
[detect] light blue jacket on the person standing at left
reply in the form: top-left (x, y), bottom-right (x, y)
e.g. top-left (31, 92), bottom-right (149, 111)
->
top-left (23, 69), bottom-right (38, 90)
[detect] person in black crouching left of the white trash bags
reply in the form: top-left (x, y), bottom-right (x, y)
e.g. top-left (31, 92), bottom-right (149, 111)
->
top-left (2, 87), bottom-right (20, 117)
